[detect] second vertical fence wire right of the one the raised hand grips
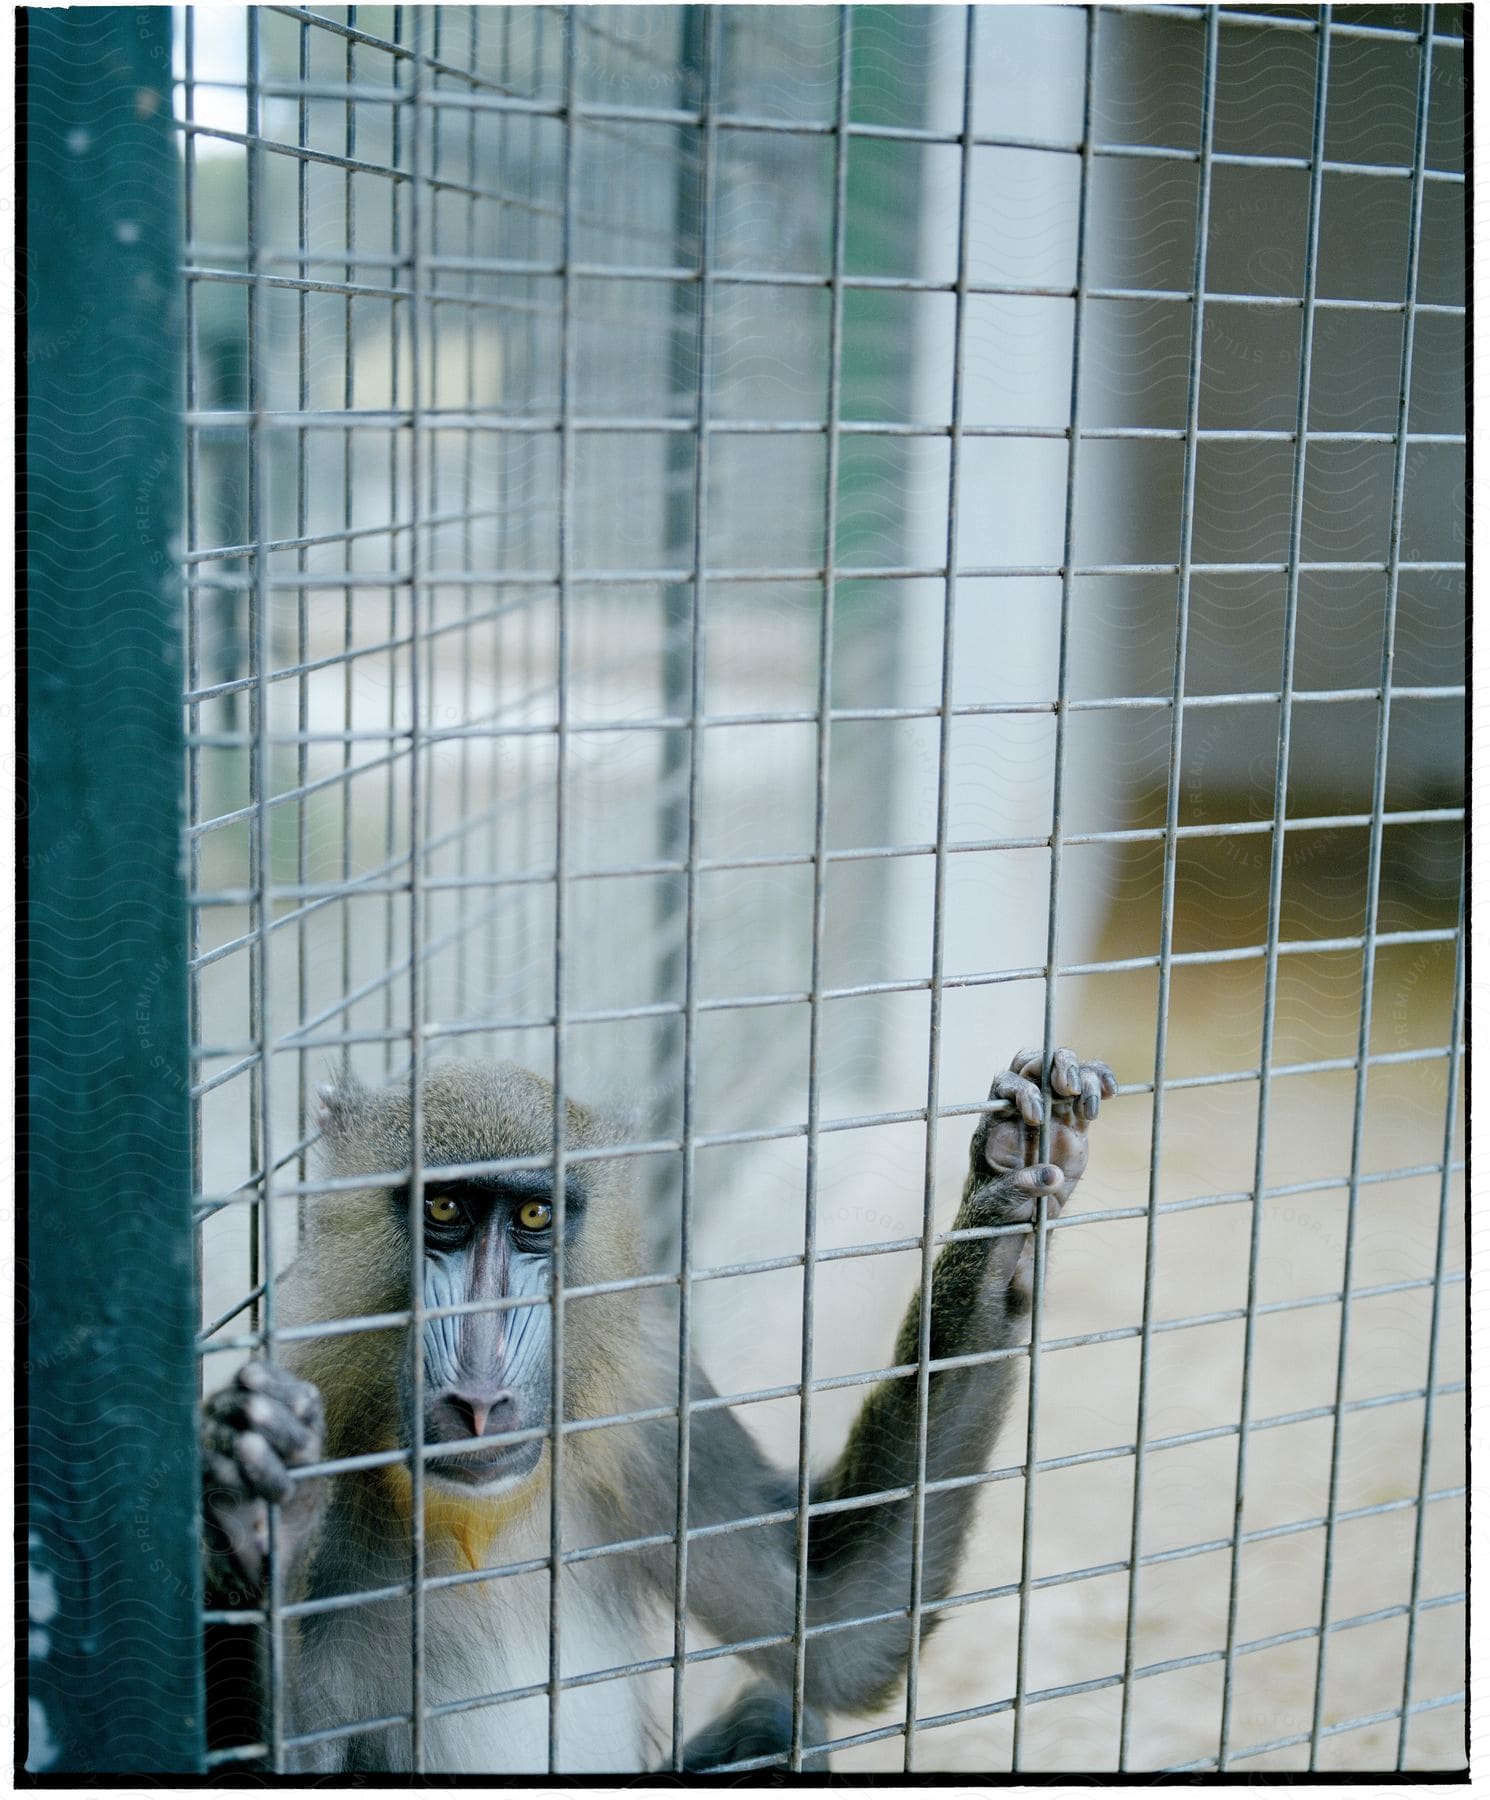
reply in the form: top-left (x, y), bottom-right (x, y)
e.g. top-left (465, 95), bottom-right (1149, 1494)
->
top-left (1216, 5), bottom-right (1332, 1773)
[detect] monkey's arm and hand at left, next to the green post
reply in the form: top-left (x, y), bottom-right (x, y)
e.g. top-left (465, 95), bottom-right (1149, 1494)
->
top-left (202, 1363), bottom-right (324, 1768)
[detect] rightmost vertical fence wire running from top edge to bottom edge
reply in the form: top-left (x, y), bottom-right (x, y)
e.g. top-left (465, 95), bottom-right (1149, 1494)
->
top-left (1308, 5), bottom-right (1454, 1768)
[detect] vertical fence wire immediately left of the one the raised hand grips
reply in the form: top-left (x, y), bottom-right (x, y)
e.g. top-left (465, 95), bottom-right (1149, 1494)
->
top-left (905, 5), bottom-right (977, 1773)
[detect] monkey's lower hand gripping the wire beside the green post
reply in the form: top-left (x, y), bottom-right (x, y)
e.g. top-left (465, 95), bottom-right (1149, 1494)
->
top-left (202, 1363), bottom-right (324, 1604)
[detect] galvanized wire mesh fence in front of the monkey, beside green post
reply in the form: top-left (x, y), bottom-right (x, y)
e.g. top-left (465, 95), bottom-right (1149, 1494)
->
top-left (176, 5), bottom-right (1465, 1771)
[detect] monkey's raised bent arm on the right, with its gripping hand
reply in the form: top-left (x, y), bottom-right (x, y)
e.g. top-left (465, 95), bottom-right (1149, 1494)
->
top-left (689, 1049), bottom-right (1118, 1768)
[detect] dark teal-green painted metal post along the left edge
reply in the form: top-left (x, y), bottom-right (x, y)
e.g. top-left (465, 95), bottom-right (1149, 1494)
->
top-left (18, 7), bottom-right (203, 1778)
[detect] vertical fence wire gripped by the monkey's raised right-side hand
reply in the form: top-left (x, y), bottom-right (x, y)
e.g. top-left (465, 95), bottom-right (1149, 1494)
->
top-left (1010, 7), bottom-right (1100, 1769)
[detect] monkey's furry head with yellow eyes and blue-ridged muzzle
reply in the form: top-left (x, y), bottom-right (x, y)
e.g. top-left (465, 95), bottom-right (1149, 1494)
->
top-left (302, 1062), bottom-right (637, 1494)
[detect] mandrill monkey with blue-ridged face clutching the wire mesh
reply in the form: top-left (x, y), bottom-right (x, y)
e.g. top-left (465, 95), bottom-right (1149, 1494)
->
top-left (202, 1049), bottom-right (1118, 1775)
